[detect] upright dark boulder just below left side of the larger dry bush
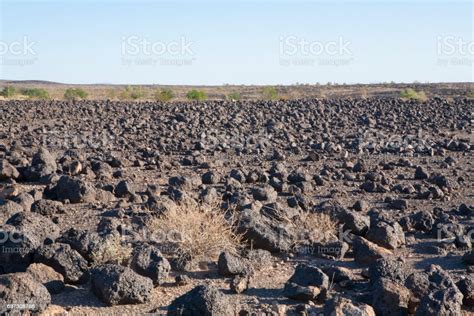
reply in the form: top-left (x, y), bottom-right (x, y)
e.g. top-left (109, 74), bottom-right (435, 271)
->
top-left (131, 245), bottom-right (171, 285)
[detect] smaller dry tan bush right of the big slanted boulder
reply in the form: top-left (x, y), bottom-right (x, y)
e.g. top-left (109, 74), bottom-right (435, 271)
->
top-left (298, 212), bottom-right (338, 242)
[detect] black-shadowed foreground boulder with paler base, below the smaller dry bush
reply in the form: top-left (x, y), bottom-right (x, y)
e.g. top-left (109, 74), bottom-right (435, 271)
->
top-left (283, 264), bottom-right (329, 301)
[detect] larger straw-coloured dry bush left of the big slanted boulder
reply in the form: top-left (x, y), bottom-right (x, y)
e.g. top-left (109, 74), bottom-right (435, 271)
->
top-left (149, 202), bottom-right (242, 264)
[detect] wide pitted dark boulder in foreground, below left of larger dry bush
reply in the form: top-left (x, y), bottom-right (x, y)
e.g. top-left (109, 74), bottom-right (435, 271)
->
top-left (91, 264), bottom-right (153, 305)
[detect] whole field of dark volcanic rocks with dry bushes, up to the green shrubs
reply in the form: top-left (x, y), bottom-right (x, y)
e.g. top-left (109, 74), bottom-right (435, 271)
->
top-left (0, 97), bottom-right (474, 316)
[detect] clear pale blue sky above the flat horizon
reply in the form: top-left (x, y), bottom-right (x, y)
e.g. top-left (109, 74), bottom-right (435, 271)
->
top-left (0, 0), bottom-right (474, 85)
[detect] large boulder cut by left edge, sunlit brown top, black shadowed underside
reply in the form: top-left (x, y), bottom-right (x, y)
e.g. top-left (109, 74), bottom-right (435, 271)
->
top-left (0, 212), bottom-right (59, 272)
